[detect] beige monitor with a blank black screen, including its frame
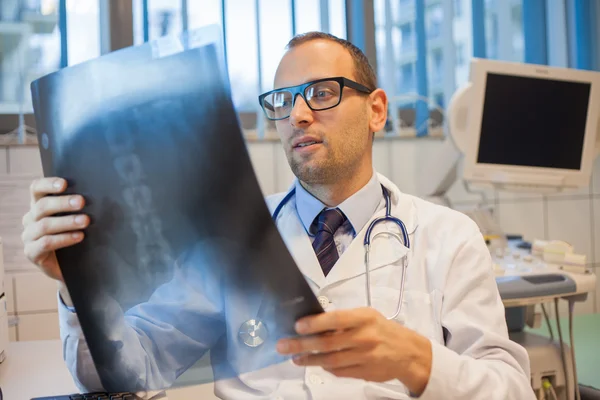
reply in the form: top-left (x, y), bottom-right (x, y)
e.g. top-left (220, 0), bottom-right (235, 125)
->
top-left (451, 59), bottom-right (600, 191)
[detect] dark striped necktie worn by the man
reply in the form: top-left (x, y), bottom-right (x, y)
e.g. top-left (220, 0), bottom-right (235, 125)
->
top-left (313, 208), bottom-right (346, 276)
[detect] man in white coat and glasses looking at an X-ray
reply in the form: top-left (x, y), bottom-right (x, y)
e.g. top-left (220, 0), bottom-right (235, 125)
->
top-left (23, 33), bottom-right (534, 400)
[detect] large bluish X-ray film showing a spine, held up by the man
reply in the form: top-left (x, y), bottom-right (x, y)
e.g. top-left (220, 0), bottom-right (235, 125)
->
top-left (32, 28), bottom-right (322, 392)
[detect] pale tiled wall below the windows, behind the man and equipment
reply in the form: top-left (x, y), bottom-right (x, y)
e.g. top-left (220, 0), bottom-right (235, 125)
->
top-left (0, 139), bottom-right (600, 340)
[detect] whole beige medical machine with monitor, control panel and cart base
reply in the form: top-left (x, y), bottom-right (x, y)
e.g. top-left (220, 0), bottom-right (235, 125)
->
top-left (426, 59), bottom-right (600, 400)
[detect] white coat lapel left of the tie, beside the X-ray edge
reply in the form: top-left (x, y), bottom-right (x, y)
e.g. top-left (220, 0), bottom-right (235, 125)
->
top-left (278, 198), bottom-right (325, 288)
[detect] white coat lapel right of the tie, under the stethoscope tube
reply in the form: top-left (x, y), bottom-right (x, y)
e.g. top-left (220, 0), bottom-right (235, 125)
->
top-left (325, 175), bottom-right (417, 286)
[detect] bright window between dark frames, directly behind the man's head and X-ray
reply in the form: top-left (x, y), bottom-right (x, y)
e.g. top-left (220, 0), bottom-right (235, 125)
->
top-left (132, 0), bottom-right (346, 135)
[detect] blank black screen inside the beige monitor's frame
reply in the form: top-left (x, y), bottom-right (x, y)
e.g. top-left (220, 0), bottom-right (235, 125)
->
top-left (477, 73), bottom-right (591, 170)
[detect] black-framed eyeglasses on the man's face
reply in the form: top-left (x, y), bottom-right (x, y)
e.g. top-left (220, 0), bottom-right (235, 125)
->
top-left (258, 77), bottom-right (373, 121)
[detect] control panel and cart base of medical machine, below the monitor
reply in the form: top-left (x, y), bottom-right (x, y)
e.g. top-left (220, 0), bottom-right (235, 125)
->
top-left (492, 240), bottom-right (596, 400)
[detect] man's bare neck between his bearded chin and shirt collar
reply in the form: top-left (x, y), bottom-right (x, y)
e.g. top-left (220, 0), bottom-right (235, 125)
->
top-left (300, 168), bottom-right (373, 207)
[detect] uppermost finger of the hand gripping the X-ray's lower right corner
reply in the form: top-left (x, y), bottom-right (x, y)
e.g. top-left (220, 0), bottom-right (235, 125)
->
top-left (296, 307), bottom-right (381, 335)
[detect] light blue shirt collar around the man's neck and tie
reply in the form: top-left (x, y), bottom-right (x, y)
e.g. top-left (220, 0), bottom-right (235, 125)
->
top-left (295, 172), bottom-right (383, 234)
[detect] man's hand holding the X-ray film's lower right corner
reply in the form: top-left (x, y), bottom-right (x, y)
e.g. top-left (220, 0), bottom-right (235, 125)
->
top-left (277, 307), bottom-right (432, 395)
